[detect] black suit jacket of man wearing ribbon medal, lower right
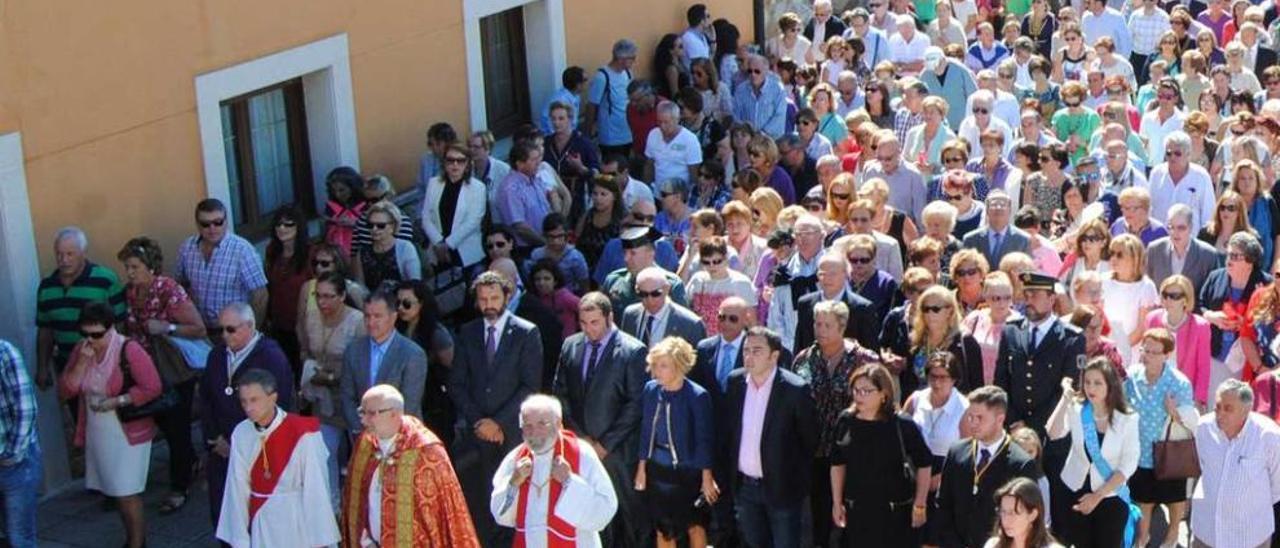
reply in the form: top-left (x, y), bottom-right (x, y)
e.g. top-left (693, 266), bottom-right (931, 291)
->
top-left (931, 438), bottom-right (1041, 548)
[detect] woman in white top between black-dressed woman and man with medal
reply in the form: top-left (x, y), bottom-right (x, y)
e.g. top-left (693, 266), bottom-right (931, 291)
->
top-left (902, 351), bottom-right (969, 544)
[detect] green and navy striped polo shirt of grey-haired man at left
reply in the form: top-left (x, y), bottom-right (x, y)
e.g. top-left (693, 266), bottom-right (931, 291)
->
top-left (36, 261), bottom-right (127, 358)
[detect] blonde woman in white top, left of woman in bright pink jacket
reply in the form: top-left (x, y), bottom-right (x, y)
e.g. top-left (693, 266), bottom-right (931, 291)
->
top-left (1102, 234), bottom-right (1160, 365)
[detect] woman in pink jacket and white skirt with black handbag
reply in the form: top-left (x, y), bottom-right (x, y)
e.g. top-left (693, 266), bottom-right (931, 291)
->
top-left (59, 302), bottom-right (163, 548)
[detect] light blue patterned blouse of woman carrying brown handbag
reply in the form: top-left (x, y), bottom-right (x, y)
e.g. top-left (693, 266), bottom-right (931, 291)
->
top-left (1124, 362), bottom-right (1196, 469)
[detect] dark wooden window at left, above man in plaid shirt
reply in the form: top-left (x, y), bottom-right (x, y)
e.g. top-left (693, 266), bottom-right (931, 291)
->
top-left (220, 78), bottom-right (315, 241)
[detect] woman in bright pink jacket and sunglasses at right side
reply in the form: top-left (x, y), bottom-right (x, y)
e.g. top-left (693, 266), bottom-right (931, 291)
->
top-left (1147, 274), bottom-right (1211, 410)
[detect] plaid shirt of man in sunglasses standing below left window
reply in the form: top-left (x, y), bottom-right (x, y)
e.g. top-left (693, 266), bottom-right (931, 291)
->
top-left (173, 234), bottom-right (266, 325)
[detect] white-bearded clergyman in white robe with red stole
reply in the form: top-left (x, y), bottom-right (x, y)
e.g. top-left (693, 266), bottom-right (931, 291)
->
top-left (489, 394), bottom-right (618, 548)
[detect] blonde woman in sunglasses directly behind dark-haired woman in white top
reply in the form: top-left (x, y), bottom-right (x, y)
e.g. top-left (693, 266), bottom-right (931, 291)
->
top-left (899, 286), bottom-right (984, 398)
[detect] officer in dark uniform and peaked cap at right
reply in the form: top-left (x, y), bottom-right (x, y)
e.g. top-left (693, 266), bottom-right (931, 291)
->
top-left (996, 273), bottom-right (1084, 537)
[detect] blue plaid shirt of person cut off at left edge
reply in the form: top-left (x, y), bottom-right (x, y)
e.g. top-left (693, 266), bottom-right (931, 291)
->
top-left (0, 341), bottom-right (37, 466)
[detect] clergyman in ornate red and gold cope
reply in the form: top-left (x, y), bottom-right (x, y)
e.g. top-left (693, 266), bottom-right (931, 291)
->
top-left (342, 384), bottom-right (480, 548)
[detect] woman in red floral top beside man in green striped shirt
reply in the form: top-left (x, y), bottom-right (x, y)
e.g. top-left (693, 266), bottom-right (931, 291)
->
top-left (116, 237), bottom-right (205, 513)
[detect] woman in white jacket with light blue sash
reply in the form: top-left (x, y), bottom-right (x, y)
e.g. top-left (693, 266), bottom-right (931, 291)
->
top-left (1046, 359), bottom-right (1142, 548)
